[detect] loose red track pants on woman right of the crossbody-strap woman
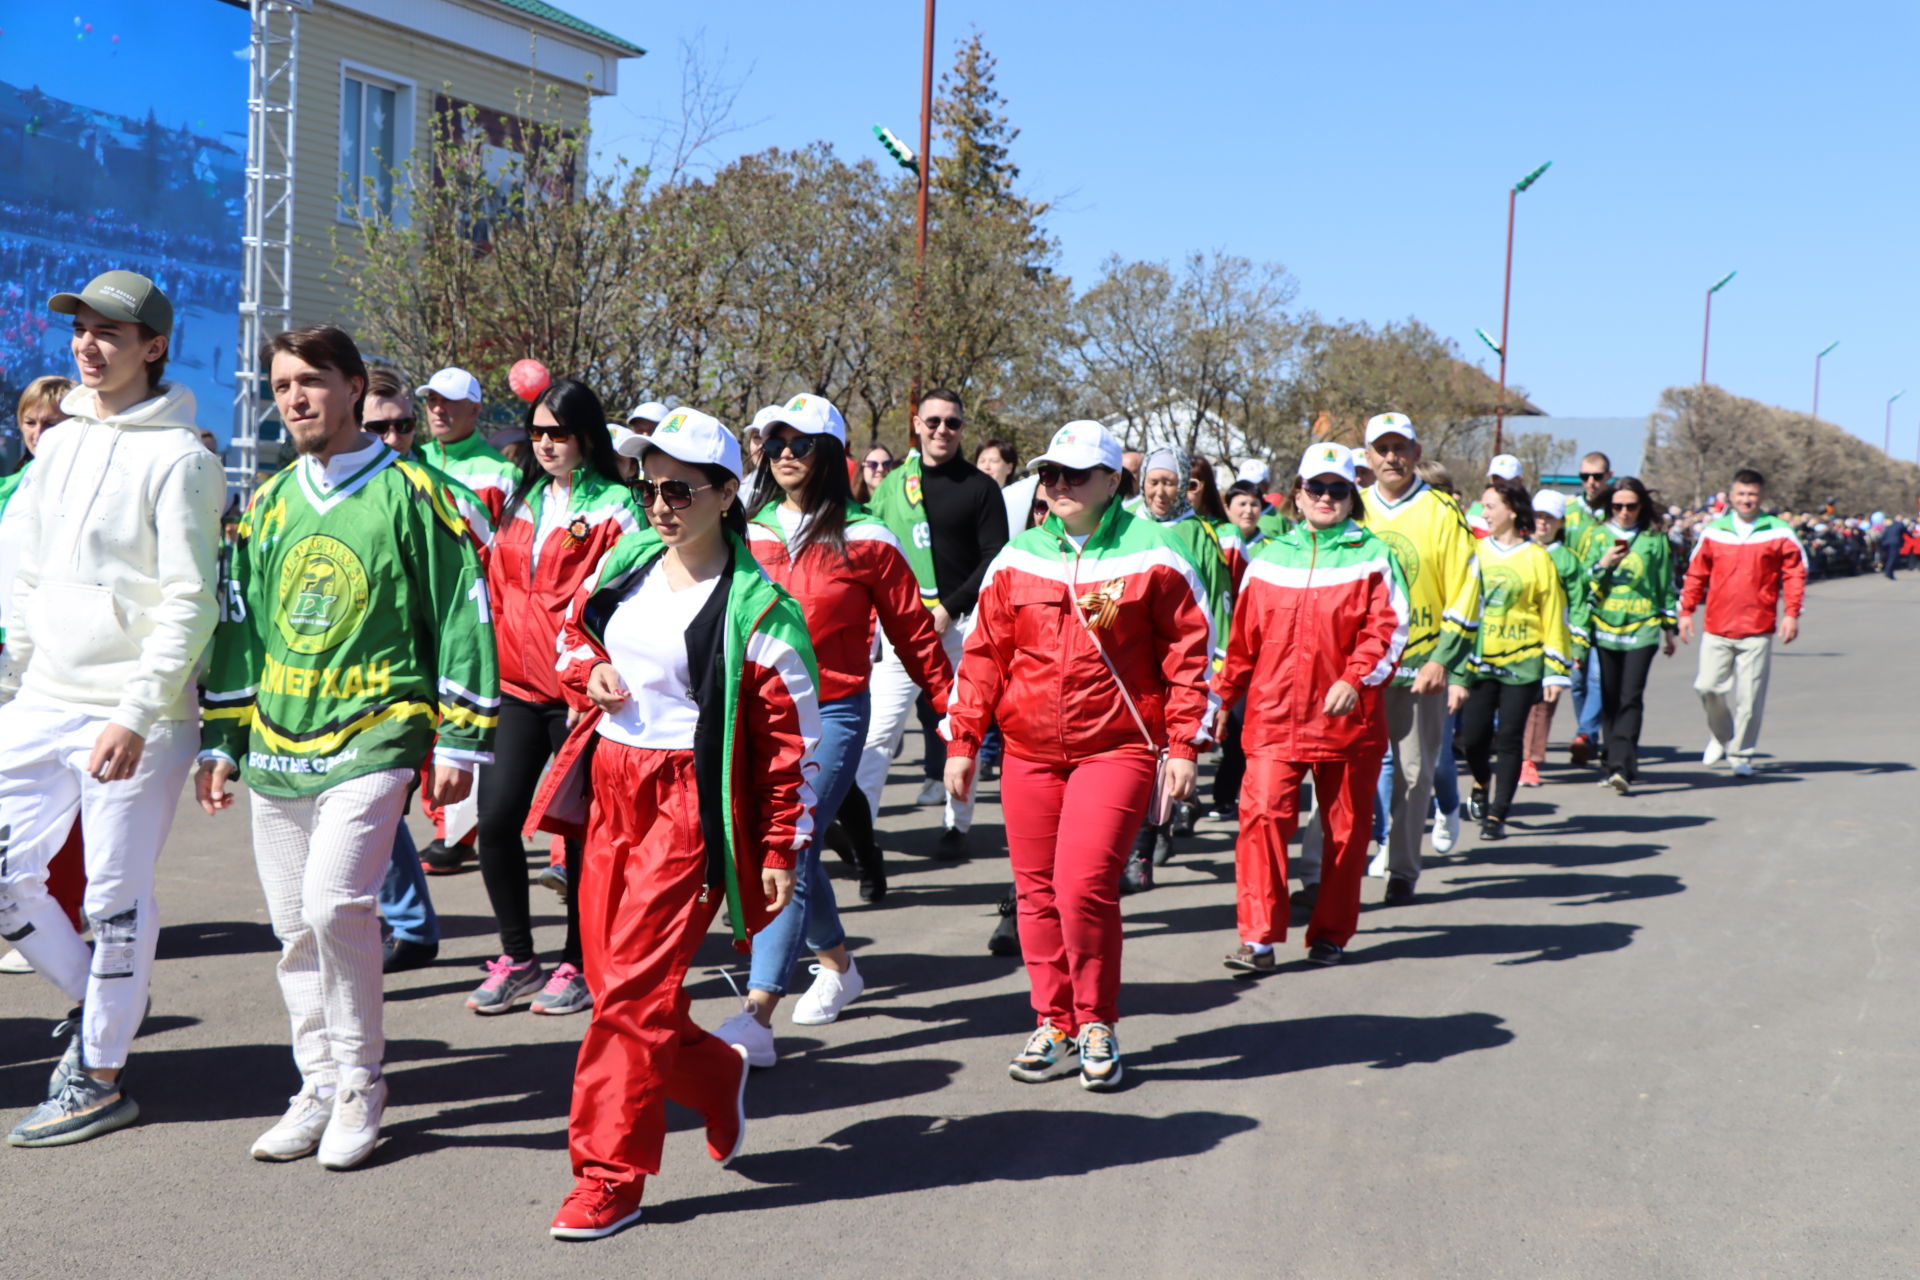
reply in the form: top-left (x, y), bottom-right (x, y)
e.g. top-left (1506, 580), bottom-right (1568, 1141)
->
top-left (1233, 754), bottom-right (1380, 946)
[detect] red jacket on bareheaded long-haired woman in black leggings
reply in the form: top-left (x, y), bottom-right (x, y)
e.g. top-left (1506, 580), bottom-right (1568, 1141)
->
top-left (486, 470), bottom-right (645, 702)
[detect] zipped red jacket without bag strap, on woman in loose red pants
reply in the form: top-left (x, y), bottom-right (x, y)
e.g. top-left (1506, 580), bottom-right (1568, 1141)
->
top-left (1213, 524), bottom-right (1409, 762)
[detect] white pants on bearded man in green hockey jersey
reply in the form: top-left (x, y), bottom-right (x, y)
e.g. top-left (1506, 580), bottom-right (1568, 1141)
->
top-left (253, 770), bottom-right (413, 1088)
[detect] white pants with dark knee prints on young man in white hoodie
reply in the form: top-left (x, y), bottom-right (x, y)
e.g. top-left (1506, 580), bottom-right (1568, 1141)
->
top-left (0, 693), bottom-right (198, 1071)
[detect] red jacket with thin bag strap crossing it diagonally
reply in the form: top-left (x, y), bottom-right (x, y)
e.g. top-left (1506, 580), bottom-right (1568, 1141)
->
top-left (947, 503), bottom-right (1213, 766)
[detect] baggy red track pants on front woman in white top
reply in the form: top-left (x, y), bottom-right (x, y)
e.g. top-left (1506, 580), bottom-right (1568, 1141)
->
top-left (566, 739), bottom-right (741, 1182)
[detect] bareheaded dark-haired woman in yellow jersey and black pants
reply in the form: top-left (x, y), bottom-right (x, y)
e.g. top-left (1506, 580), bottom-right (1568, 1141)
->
top-left (1448, 480), bottom-right (1572, 841)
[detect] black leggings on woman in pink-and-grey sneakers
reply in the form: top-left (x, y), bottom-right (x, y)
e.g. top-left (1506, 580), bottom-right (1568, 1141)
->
top-left (478, 695), bottom-right (580, 967)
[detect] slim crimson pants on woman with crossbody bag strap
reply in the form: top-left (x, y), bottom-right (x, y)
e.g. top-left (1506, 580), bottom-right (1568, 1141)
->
top-left (1000, 750), bottom-right (1154, 1036)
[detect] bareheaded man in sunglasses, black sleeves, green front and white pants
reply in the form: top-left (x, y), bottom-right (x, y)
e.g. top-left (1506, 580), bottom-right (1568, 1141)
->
top-left (854, 388), bottom-right (1006, 858)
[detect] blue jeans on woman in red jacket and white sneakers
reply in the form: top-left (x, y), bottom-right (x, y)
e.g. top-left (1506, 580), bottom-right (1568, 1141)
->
top-left (747, 691), bottom-right (872, 996)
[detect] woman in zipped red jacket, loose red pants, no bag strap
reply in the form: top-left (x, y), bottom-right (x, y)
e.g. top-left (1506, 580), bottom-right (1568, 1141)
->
top-left (1213, 443), bottom-right (1407, 973)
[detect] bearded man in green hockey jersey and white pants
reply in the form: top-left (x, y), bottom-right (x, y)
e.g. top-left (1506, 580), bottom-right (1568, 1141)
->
top-left (196, 326), bottom-right (499, 1169)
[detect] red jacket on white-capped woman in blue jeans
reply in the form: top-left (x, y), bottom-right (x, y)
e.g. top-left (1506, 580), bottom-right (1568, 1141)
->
top-left (747, 516), bottom-right (954, 716)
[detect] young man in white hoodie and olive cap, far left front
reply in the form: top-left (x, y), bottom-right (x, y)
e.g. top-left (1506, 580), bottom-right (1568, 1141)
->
top-left (0, 271), bottom-right (227, 1146)
